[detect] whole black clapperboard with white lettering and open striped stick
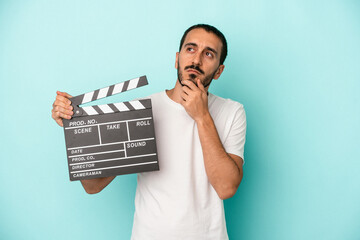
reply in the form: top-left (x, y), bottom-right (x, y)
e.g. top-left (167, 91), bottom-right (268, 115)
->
top-left (63, 76), bottom-right (159, 181)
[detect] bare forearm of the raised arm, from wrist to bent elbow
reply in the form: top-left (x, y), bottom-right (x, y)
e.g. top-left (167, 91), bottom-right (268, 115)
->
top-left (197, 114), bottom-right (242, 199)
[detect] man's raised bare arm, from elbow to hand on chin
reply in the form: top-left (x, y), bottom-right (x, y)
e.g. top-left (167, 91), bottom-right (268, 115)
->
top-left (181, 80), bottom-right (243, 199)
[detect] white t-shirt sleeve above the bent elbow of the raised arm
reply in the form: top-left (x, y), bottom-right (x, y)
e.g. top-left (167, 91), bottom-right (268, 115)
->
top-left (223, 105), bottom-right (246, 163)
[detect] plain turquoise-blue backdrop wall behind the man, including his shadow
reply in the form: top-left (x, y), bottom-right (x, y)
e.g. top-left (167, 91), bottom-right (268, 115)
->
top-left (0, 0), bottom-right (360, 240)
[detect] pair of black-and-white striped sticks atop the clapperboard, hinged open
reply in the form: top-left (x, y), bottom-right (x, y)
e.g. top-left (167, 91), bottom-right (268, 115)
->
top-left (70, 76), bottom-right (151, 117)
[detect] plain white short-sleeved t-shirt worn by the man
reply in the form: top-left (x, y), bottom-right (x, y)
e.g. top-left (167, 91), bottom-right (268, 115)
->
top-left (132, 91), bottom-right (246, 240)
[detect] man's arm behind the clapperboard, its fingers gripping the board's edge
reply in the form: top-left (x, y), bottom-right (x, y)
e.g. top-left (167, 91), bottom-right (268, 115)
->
top-left (51, 91), bottom-right (115, 194)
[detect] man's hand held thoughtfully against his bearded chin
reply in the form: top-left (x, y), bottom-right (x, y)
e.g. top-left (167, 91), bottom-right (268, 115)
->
top-left (181, 78), bottom-right (210, 122)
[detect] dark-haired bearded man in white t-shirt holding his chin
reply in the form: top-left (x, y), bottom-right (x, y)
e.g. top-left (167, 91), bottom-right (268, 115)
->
top-left (52, 24), bottom-right (246, 240)
